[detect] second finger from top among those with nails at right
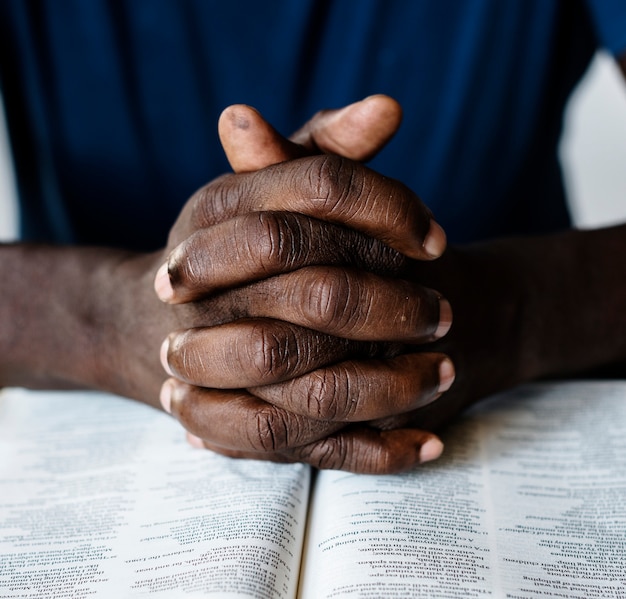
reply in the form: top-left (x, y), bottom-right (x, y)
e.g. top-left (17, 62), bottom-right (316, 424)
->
top-left (221, 266), bottom-right (452, 343)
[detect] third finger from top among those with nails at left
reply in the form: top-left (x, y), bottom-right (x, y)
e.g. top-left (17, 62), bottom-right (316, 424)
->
top-left (161, 378), bottom-right (343, 453)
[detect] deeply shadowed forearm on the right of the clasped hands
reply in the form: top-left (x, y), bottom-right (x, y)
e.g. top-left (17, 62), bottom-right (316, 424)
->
top-left (426, 226), bottom-right (626, 403)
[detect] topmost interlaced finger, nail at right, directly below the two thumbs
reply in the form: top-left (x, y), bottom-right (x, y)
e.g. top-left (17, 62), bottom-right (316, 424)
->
top-left (190, 155), bottom-right (446, 260)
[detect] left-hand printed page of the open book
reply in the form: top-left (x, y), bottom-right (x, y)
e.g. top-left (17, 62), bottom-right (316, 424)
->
top-left (0, 390), bottom-right (309, 599)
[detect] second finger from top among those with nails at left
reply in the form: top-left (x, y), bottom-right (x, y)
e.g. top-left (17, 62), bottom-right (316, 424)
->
top-left (161, 319), bottom-right (381, 389)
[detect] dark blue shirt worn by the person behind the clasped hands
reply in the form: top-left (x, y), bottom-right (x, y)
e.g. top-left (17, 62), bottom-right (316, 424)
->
top-left (0, 0), bottom-right (626, 249)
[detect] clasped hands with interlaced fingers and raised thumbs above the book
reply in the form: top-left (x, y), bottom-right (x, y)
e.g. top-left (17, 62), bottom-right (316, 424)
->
top-left (155, 96), bottom-right (454, 473)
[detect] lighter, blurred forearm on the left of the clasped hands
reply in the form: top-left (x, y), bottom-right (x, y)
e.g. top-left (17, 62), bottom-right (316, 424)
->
top-left (0, 244), bottom-right (167, 408)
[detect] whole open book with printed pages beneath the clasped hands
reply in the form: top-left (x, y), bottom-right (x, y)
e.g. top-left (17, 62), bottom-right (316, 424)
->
top-left (0, 382), bottom-right (626, 599)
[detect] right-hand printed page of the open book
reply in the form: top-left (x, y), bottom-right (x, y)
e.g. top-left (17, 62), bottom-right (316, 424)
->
top-left (301, 383), bottom-right (626, 599)
